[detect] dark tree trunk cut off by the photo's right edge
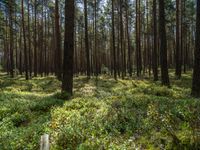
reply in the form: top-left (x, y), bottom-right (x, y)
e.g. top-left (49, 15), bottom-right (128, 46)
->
top-left (192, 0), bottom-right (200, 97)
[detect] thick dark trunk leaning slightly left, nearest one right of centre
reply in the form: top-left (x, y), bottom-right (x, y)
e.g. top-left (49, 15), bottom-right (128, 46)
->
top-left (159, 0), bottom-right (170, 86)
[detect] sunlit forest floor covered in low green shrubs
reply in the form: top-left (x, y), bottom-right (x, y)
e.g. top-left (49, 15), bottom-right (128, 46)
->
top-left (0, 73), bottom-right (200, 150)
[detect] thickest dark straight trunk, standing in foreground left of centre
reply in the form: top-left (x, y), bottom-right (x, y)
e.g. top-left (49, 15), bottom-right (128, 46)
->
top-left (62, 0), bottom-right (75, 95)
